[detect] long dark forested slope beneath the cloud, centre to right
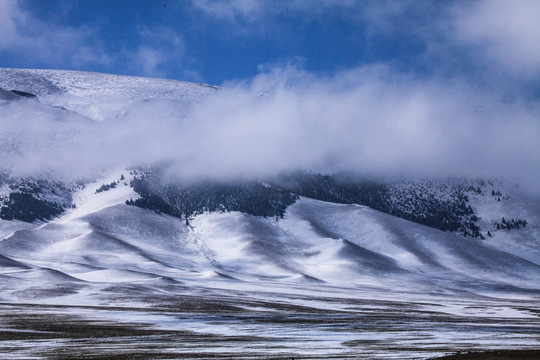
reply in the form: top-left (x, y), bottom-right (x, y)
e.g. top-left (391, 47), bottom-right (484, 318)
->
top-left (123, 170), bottom-right (502, 237)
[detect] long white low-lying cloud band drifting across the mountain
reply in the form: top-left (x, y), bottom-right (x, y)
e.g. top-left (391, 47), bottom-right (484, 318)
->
top-left (0, 65), bottom-right (540, 191)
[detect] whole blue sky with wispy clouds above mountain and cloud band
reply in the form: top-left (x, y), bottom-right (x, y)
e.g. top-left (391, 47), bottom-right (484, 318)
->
top-left (0, 0), bottom-right (540, 90)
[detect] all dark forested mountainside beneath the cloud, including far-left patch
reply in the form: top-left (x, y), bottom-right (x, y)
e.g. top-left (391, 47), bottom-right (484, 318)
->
top-left (0, 162), bottom-right (516, 238)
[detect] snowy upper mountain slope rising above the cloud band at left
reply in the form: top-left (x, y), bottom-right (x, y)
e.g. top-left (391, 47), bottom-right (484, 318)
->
top-left (0, 68), bottom-right (216, 121)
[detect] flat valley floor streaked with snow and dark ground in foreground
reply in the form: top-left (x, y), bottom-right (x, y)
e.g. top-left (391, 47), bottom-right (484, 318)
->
top-left (0, 283), bottom-right (540, 360)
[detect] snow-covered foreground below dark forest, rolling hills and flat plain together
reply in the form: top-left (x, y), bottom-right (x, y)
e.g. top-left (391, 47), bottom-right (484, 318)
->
top-left (0, 171), bottom-right (540, 359)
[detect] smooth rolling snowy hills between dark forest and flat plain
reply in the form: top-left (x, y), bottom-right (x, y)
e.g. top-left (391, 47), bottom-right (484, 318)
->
top-left (0, 179), bottom-right (540, 291)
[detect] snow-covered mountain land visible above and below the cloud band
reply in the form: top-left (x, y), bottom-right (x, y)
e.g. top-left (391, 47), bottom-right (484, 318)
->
top-left (0, 69), bottom-right (540, 359)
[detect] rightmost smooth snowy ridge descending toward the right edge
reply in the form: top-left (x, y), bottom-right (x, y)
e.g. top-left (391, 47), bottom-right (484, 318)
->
top-left (282, 200), bottom-right (539, 282)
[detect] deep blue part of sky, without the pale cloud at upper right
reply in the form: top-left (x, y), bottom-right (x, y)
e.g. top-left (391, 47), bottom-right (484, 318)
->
top-left (0, 0), bottom-right (400, 84)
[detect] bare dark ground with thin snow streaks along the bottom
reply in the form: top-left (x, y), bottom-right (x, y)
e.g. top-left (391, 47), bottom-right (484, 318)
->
top-left (0, 293), bottom-right (540, 360)
